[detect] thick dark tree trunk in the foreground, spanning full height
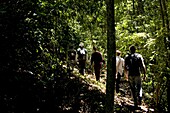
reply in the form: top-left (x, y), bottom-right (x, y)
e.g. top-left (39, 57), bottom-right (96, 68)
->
top-left (105, 0), bottom-right (116, 113)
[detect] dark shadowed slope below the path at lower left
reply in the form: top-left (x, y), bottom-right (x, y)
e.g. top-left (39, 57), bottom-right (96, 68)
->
top-left (0, 71), bottom-right (154, 113)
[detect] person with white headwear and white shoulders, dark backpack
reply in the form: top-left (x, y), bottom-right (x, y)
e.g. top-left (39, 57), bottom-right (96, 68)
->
top-left (77, 42), bottom-right (88, 75)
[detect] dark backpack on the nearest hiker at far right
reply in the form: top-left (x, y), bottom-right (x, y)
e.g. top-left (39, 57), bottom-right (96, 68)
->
top-left (125, 53), bottom-right (142, 76)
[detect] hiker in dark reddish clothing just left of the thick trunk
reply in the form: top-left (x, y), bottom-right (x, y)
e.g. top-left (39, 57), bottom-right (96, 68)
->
top-left (91, 47), bottom-right (105, 81)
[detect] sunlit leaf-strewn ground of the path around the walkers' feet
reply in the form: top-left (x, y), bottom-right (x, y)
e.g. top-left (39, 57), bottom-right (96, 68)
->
top-left (69, 66), bottom-right (154, 113)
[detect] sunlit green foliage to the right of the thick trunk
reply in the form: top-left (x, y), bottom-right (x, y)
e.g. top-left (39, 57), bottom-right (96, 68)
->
top-left (116, 0), bottom-right (169, 111)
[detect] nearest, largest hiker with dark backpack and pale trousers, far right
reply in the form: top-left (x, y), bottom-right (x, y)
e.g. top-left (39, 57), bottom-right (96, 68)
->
top-left (124, 45), bottom-right (146, 108)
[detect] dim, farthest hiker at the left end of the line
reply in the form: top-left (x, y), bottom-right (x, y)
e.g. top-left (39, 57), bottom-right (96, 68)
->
top-left (68, 45), bottom-right (76, 71)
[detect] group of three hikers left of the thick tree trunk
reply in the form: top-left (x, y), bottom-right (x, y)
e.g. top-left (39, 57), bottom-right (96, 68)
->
top-left (69, 43), bottom-right (106, 78)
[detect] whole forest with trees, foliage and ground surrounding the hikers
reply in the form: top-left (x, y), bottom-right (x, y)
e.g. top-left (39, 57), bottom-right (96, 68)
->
top-left (0, 0), bottom-right (170, 113)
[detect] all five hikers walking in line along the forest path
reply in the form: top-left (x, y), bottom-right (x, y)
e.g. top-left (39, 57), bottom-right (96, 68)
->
top-left (69, 42), bottom-right (146, 107)
